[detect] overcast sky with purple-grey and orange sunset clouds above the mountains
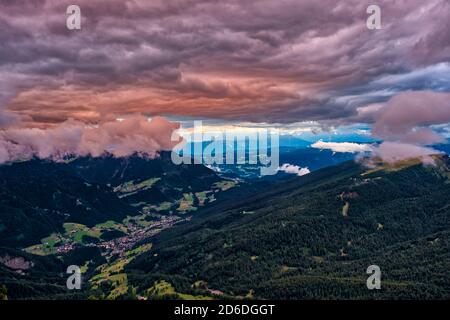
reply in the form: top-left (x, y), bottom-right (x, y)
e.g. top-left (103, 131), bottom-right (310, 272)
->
top-left (0, 0), bottom-right (450, 162)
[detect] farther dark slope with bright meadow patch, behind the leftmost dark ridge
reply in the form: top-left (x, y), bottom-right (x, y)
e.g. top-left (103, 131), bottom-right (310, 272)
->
top-left (67, 152), bottom-right (222, 208)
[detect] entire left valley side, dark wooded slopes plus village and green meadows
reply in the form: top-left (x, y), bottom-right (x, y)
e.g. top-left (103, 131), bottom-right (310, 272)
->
top-left (0, 153), bottom-right (234, 299)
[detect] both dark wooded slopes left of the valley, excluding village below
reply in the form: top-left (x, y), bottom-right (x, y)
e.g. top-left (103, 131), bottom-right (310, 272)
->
top-left (0, 153), bottom-right (223, 248)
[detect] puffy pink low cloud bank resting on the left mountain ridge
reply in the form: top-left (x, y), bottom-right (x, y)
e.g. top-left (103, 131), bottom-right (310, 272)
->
top-left (0, 115), bottom-right (183, 163)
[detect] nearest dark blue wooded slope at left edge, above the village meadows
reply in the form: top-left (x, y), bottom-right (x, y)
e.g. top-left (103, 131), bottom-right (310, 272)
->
top-left (0, 160), bottom-right (137, 247)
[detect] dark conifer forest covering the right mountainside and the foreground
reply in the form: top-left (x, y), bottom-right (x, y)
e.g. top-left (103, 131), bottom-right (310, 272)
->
top-left (0, 156), bottom-right (450, 299)
